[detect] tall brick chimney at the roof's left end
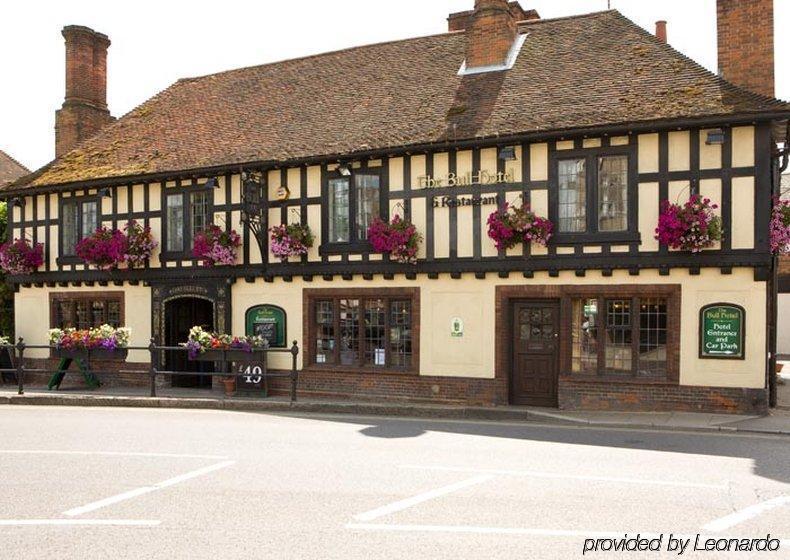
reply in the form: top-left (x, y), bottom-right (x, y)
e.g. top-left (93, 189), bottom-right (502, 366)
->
top-left (55, 25), bottom-right (114, 157)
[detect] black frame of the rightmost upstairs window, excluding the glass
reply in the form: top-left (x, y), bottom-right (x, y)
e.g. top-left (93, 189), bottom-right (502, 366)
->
top-left (549, 144), bottom-right (641, 244)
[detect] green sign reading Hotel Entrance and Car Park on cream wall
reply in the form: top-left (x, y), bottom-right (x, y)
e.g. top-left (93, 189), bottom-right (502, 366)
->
top-left (699, 303), bottom-right (746, 360)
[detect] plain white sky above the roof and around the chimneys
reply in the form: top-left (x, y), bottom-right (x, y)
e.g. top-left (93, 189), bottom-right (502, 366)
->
top-left (0, 0), bottom-right (790, 169)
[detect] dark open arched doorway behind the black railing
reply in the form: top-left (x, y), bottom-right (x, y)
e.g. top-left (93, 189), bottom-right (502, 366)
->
top-left (165, 297), bottom-right (214, 389)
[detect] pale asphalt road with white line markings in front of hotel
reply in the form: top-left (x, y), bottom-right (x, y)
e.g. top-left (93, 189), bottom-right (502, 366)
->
top-left (0, 406), bottom-right (790, 560)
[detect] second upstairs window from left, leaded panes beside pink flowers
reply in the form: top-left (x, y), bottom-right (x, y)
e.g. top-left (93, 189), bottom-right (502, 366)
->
top-left (165, 189), bottom-right (214, 256)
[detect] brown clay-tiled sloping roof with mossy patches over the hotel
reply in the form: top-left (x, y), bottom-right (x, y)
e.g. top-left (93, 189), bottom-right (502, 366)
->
top-left (6, 11), bottom-right (790, 187)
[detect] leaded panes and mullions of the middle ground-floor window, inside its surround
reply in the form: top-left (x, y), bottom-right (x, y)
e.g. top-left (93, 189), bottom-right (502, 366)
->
top-left (308, 292), bottom-right (417, 371)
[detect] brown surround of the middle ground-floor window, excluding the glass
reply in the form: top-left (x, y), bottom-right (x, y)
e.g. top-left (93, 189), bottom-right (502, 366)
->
top-left (303, 288), bottom-right (420, 375)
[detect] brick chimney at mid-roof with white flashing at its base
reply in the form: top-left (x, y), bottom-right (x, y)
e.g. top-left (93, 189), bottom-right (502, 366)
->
top-left (458, 0), bottom-right (525, 69)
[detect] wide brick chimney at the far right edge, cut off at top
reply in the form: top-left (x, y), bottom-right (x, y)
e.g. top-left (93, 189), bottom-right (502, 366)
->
top-left (716, 0), bottom-right (774, 97)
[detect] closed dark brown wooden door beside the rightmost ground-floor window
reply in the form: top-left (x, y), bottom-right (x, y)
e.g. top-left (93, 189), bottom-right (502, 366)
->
top-left (510, 301), bottom-right (560, 407)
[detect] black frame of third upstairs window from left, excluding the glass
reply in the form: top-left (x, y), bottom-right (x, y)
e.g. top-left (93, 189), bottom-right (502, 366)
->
top-left (318, 165), bottom-right (389, 255)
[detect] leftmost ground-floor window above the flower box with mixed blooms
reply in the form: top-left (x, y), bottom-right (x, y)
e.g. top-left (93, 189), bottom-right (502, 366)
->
top-left (49, 292), bottom-right (124, 329)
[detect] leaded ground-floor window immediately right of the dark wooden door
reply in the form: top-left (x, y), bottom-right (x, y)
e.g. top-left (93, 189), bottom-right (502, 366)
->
top-left (570, 297), bottom-right (669, 379)
